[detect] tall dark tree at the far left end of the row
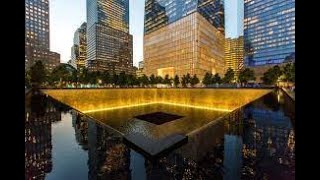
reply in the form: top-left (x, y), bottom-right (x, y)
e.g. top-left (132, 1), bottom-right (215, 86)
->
top-left (30, 61), bottom-right (47, 88)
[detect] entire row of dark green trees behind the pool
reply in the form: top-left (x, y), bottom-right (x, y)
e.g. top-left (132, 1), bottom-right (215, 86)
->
top-left (25, 61), bottom-right (295, 87)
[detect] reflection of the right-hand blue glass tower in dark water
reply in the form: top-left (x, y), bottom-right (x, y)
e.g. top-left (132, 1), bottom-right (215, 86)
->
top-left (243, 102), bottom-right (294, 178)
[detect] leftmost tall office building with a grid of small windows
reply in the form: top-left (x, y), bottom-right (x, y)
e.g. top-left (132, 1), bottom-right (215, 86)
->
top-left (25, 0), bottom-right (60, 71)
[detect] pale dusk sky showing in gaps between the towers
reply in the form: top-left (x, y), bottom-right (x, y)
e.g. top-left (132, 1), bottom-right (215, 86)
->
top-left (49, 0), bottom-right (243, 66)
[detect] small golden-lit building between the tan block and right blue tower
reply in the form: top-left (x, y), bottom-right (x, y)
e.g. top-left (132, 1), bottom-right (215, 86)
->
top-left (225, 36), bottom-right (243, 77)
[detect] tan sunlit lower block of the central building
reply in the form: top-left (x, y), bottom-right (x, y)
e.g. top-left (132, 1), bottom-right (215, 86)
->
top-left (144, 12), bottom-right (225, 79)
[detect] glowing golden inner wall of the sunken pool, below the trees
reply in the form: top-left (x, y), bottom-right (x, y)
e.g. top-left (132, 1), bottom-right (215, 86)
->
top-left (42, 89), bottom-right (271, 112)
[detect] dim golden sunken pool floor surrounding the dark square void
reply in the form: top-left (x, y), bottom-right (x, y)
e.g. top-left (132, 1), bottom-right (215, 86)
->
top-left (86, 104), bottom-right (227, 139)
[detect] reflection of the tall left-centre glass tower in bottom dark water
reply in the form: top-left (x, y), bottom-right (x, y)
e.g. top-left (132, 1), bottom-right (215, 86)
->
top-left (88, 121), bottom-right (130, 179)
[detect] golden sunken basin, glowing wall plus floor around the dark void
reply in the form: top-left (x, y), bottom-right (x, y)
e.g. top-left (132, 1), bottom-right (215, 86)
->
top-left (43, 89), bottom-right (271, 139)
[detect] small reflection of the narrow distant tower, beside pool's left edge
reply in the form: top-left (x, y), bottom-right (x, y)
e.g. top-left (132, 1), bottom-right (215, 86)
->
top-left (71, 111), bottom-right (88, 150)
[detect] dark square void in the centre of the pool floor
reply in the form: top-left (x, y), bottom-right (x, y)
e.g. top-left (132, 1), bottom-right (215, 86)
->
top-left (134, 112), bottom-right (183, 125)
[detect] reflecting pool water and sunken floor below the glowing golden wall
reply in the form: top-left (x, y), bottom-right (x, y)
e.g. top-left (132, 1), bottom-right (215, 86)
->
top-left (25, 91), bottom-right (295, 179)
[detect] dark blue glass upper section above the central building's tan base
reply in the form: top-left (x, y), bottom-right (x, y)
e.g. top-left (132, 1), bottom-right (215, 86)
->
top-left (144, 0), bottom-right (224, 34)
